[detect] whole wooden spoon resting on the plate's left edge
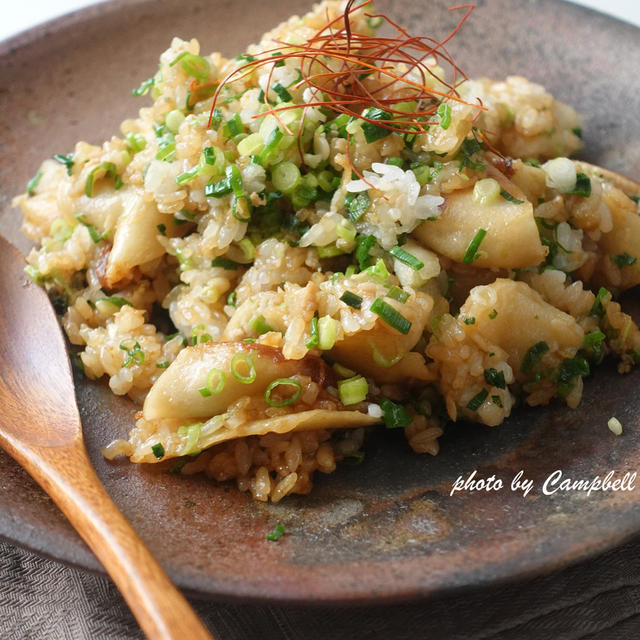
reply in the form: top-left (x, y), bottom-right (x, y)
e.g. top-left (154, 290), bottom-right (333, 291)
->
top-left (0, 236), bottom-right (212, 640)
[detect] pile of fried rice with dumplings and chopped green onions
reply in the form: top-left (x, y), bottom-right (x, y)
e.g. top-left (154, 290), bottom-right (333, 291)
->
top-left (16, 0), bottom-right (640, 502)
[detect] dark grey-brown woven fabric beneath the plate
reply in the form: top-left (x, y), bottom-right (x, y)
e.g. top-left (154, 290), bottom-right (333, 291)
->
top-left (0, 538), bottom-right (640, 640)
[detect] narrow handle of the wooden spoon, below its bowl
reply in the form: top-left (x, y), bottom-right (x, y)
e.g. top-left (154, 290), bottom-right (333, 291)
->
top-left (3, 440), bottom-right (213, 640)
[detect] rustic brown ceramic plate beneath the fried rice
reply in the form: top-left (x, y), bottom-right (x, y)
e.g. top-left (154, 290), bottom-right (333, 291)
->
top-left (0, 0), bottom-right (640, 601)
